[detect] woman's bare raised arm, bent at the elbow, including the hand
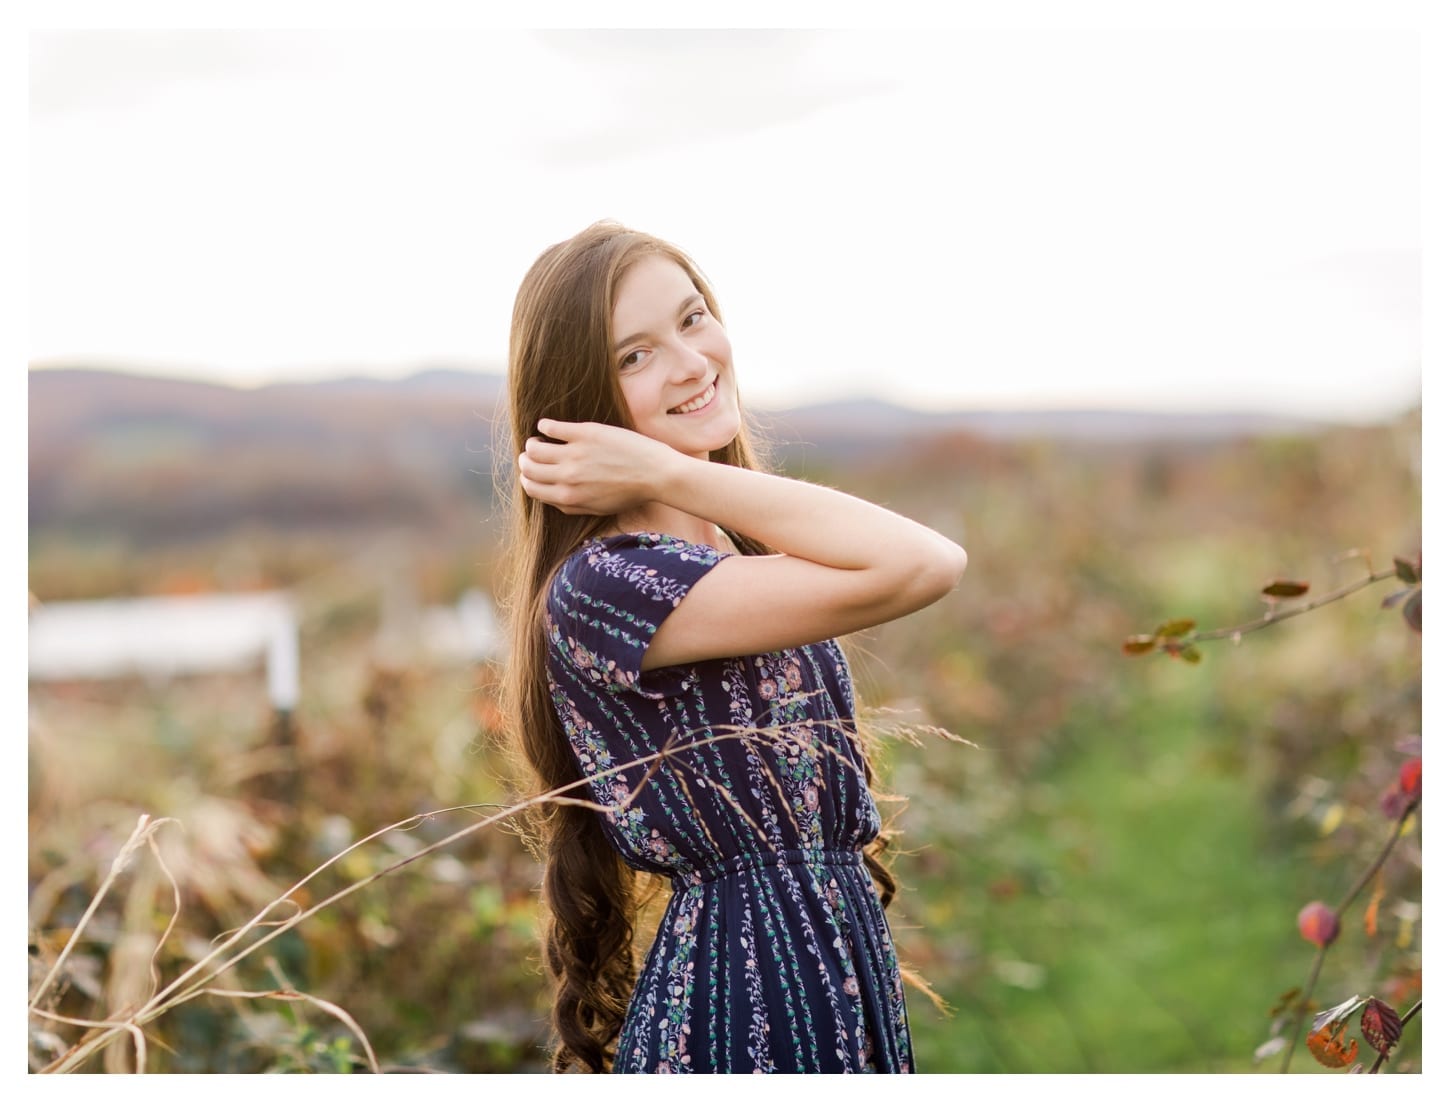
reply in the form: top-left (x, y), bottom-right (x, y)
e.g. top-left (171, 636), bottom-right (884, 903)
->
top-left (519, 421), bottom-right (967, 670)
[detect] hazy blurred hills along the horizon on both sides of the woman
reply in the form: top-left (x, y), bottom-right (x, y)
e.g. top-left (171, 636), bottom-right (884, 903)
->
top-left (29, 367), bottom-right (1321, 544)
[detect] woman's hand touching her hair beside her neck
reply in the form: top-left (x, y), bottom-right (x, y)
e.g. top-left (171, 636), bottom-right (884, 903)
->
top-left (519, 419), bottom-right (679, 516)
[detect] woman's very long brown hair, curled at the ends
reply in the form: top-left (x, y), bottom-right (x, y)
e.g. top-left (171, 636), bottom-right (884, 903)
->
top-left (500, 222), bottom-right (896, 1072)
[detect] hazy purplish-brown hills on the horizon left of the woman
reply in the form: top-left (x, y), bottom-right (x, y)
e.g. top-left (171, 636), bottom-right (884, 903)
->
top-left (29, 370), bottom-right (500, 544)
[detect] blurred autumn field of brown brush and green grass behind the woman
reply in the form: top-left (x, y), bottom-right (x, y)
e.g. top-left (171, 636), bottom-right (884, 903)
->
top-left (29, 382), bottom-right (1421, 1073)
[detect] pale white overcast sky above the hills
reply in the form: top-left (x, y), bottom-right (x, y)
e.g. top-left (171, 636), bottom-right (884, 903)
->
top-left (29, 30), bottom-right (1421, 419)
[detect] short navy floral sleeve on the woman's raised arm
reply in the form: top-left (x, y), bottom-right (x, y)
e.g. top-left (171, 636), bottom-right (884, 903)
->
top-left (547, 534), bottom-right (725, 697)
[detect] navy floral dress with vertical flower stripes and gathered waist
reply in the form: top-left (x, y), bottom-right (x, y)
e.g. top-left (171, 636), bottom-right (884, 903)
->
top-left (545, 534), bottom-right (912, 1072)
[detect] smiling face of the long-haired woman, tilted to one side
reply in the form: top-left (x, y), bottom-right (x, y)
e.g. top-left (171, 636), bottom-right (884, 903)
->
top-left (610, 254), bottom-right (740, 458)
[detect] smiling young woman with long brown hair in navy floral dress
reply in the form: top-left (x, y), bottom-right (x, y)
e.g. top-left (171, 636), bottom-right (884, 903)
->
top-left (509, 222), bottom-right (966, 1072)
